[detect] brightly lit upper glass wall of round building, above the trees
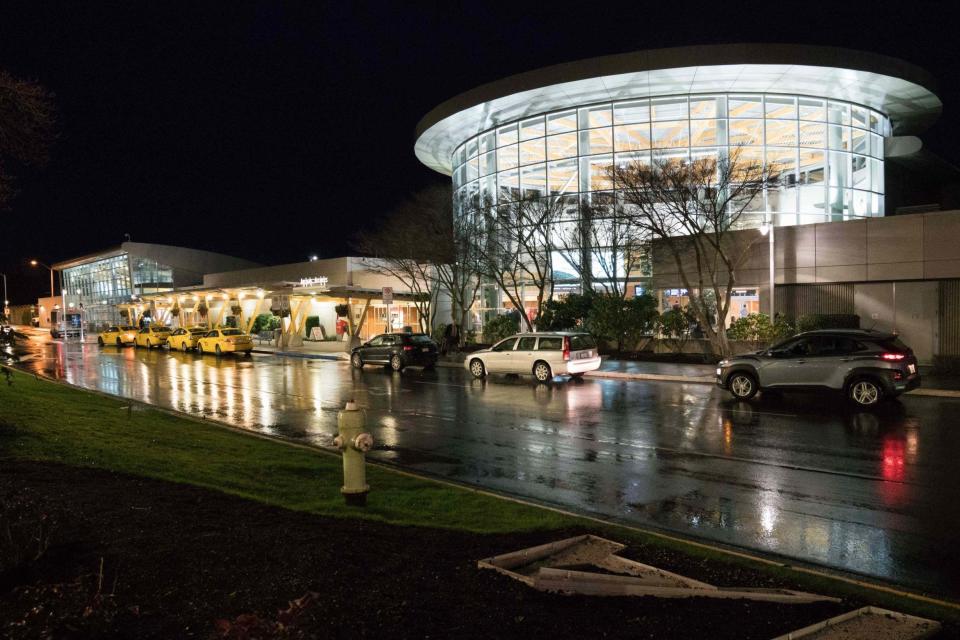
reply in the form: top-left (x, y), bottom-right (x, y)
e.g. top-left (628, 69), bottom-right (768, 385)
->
top-left (452, 93), bottom-right (891, 227)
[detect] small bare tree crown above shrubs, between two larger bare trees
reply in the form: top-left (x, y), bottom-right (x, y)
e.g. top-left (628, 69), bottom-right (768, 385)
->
top-left (557, 199), bottom-right (650, 298)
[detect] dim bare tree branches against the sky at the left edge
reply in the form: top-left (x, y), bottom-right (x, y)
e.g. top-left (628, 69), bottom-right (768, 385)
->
top-left (0, 70), bottom-right (56, 208)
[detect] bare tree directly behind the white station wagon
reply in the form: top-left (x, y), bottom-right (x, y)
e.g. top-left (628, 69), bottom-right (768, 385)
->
top-left (474, 196), bottom-right (569, 330)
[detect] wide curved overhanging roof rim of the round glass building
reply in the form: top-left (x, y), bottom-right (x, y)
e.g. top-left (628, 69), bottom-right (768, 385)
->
top-left (415, 44), bottom-right (942, 175)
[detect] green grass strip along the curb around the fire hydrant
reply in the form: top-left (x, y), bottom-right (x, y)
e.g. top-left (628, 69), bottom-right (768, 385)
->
top-left (0, 369), bottom-right (960, 624)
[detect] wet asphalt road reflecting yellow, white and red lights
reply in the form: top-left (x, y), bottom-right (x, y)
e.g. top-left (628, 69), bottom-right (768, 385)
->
top-left (7, 341), bottom-right (960, 598)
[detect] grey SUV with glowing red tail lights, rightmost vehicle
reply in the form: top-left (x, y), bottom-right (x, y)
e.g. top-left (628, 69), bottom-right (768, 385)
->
top-left (717, 329), bottom-right (920, 406)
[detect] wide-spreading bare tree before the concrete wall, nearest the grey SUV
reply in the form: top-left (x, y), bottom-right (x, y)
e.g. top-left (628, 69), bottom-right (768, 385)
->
top-left (609, 149), bottom-right (778, 356)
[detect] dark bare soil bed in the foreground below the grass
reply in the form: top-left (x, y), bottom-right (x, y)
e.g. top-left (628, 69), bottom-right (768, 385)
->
top-left (0, 461), bottom-right (936, 640)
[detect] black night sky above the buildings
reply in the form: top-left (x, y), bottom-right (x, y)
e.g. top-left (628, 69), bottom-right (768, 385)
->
top-left (0, 1), bottom-right (960, 303)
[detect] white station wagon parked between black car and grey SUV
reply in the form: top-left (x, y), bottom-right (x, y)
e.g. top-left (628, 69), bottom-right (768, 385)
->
top-left (464, 332), bottom-right (600, 382)
